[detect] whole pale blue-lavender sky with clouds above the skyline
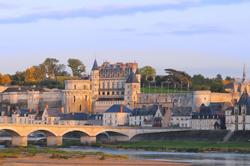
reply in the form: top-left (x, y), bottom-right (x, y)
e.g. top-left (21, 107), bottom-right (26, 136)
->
top-left (0, 0), bottom-right (250, 77)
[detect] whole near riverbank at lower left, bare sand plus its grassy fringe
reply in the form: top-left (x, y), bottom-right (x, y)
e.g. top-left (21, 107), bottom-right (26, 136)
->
top-left (0, 147), bottom-right (188, 166)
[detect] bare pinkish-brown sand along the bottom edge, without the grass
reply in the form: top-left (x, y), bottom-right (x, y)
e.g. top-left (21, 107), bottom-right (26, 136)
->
top-left (0, 155), bottom-right (188, 166)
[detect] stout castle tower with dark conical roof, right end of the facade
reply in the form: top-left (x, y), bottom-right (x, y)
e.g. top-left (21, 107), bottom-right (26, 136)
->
top-left (124, 72), bottom-right (141, 108)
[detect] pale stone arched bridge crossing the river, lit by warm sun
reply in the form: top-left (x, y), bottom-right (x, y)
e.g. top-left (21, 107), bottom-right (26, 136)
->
top-left (0, 124), bottom-right (187, 146)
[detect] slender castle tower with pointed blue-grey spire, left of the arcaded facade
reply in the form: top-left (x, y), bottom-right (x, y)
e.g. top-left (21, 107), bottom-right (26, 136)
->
top-left (91, 59), bottom-right (100, 100)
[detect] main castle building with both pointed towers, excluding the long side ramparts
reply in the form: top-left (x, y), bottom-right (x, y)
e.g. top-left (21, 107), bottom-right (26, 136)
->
top-left (63, 60), bottom-right (141, 112)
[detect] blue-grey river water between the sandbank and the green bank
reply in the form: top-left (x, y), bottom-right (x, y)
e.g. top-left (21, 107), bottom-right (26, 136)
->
top-left (62, 146), bottom-right (250, 166)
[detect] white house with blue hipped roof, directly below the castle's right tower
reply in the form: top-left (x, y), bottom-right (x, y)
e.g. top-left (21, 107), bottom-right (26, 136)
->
top-left (103, 105), bottom-right (132, 126)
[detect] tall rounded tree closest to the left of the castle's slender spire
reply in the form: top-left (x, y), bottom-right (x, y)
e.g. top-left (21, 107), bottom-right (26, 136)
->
top-left (68, 59), bottom-right (85, 77)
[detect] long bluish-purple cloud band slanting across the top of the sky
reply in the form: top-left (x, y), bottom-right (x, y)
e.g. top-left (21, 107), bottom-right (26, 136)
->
top-left (0, 0), bottom-right (249, 24)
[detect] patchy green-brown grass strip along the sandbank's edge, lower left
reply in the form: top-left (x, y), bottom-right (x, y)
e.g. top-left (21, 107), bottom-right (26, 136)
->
top-left (0, 146), bottom-right (128, 160)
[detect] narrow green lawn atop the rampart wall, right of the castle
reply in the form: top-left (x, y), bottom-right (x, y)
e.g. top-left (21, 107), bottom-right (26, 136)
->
top-left (141, 87), bottom-right (189, 93)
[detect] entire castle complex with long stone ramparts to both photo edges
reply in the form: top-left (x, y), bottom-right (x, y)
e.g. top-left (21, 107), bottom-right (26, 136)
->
top-left (0, 60), bottom-right (250, 113)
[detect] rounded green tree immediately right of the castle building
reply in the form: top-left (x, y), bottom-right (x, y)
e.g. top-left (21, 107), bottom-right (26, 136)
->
top-left (140, 66), bottom-right (156, 83)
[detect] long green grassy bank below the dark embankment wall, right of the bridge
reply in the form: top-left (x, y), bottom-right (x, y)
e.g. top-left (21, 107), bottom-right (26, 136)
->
top-left (99, 141), bottom-right (250, 153)
